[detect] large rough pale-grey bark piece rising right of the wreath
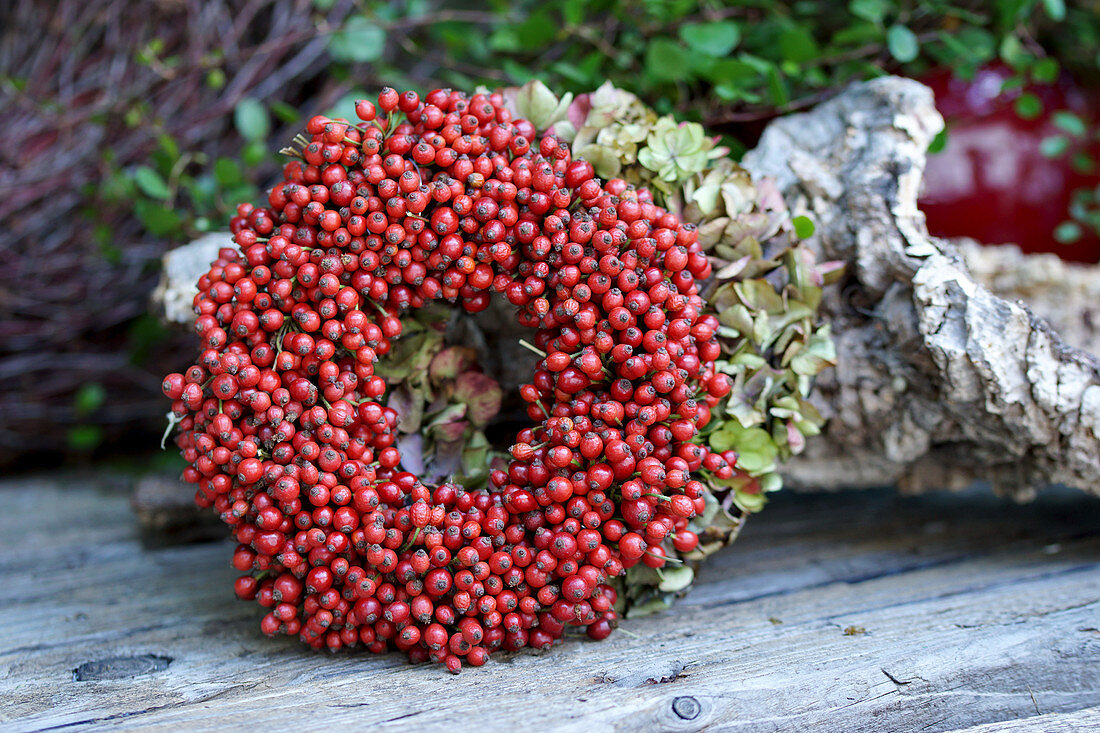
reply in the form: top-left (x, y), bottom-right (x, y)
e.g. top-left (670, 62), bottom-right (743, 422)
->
top-left (744, 77), bottom-right (1100, 499)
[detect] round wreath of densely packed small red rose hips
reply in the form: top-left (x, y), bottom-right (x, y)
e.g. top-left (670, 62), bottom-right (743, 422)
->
top-left (163, 88), bottom-right (734, 671)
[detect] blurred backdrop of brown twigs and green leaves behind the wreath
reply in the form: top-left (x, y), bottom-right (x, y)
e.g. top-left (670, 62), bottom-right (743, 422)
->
top-left (0, 0), bottom-right (1100, 467)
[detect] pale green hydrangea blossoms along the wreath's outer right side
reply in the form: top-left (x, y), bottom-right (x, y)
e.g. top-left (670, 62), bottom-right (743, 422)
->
top-left (504, 81), bottom-right (842, 581)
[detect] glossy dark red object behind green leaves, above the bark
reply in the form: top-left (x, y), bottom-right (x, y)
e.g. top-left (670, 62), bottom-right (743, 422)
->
top-left (920, 65), bottom-right (1100, 262)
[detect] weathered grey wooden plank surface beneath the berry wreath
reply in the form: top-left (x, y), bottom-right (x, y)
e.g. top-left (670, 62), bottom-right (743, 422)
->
top-left (0, 474), bottom-right (1100, 732)
